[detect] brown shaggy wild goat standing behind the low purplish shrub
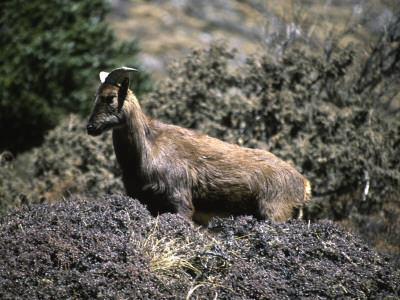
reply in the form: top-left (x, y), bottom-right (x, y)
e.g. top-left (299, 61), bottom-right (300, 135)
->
top-left (87, 67), bottom-right (311, 224)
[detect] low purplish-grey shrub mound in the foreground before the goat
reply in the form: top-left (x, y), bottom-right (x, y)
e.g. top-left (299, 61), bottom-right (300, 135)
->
top-left (0, 195), bottom-right (400, 299)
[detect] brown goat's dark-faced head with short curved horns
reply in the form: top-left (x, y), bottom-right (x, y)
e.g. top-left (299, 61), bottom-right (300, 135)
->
top-left (86, 67), bottom-right (136, 136)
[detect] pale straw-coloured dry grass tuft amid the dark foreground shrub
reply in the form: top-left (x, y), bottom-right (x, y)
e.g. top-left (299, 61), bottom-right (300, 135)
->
top-left (131, 218), bottom-right (234, 299)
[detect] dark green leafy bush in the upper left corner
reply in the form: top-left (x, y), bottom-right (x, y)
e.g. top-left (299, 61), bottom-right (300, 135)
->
top-left (0, 0), bottom-right (147, 153)
